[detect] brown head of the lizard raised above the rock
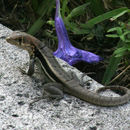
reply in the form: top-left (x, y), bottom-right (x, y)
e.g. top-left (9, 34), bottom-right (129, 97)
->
top-left (6, 31), bottom-right (34, 52)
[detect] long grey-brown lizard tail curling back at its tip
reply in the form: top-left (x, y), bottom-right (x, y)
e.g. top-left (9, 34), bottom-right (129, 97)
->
top-left (66, 80), bottom-right (130, 107)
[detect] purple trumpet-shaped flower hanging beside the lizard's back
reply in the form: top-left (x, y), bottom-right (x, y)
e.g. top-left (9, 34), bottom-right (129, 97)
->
top-left (53, 0), bottom-right (102, 65)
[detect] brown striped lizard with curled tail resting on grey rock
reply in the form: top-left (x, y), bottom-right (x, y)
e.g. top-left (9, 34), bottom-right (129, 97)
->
top-left (6, 31), bottom-right (130, 107)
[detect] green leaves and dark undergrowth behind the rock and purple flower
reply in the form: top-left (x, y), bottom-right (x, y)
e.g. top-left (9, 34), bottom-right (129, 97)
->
top-left (0, 0), bottom-right (130, 88)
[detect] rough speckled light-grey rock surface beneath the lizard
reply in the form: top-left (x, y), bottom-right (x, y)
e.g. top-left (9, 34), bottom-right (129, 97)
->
top-left (0, 24), bottom-right (130, 130)
